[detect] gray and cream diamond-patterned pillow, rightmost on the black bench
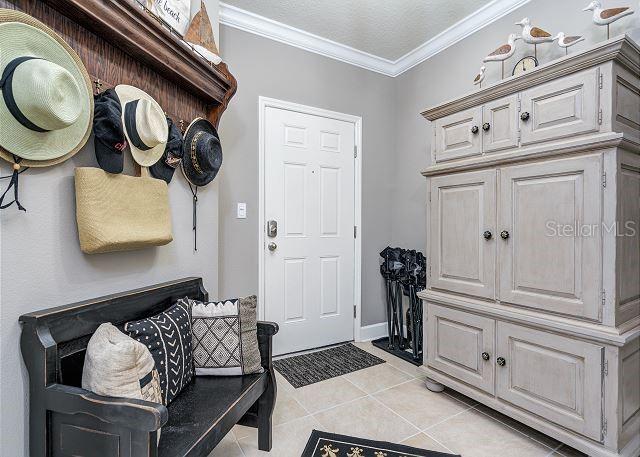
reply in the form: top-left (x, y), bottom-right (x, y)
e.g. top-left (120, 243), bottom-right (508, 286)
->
top-left (189, 295), bottom-right (262, 376)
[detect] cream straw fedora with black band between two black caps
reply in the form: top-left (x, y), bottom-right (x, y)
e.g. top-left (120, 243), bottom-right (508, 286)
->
top-left (115, 84), bottom-right (169, 167)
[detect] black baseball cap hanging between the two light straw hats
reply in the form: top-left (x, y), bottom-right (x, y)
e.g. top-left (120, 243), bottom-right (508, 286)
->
top-left (93, 89), bottom-right (127, 173)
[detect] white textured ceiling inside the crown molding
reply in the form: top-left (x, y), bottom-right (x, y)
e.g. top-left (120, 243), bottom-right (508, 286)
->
top-left (224, 0), bottom-right (496, 61)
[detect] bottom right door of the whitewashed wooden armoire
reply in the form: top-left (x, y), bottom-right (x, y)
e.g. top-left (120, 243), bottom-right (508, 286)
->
top-left (496, 322), bottom-right (604, 441)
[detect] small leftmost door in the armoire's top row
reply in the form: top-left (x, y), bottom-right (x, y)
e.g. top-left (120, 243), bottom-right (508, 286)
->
top-left (434, 106), bottom-right (482, 162)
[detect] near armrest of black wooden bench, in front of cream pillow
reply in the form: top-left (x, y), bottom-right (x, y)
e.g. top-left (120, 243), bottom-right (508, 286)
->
top-left (45, 384), bottom-right (169, 432)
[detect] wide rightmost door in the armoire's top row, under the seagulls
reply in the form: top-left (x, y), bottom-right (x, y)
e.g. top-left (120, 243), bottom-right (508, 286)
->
top-left (520, 68), bottom-right (600, 145)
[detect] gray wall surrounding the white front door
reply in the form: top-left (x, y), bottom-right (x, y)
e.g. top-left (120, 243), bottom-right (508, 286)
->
top-left (220, 26), bottom-right (396, 325)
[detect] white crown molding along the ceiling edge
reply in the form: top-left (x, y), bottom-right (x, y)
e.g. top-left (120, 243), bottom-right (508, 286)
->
top-left (220, 0), bottom-right (530, 77)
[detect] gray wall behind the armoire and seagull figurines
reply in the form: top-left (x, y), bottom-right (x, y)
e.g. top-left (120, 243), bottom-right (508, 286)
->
top-left (392, 0), bottom-right (640, 246)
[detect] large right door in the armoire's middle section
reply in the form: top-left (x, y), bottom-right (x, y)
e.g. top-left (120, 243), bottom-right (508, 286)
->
top-left (497, 155), bottom-right (603, 320)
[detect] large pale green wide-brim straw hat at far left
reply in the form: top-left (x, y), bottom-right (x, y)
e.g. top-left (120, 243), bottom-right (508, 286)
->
top-left (0, 9), bottom-right (93, 167)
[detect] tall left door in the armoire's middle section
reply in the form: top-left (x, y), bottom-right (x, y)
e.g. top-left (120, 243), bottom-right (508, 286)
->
top-left (429, 170), bottom-right (496, 298)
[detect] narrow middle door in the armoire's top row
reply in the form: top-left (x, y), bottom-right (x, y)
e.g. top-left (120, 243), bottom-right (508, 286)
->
top-left (482, 95), bottom-right (518, 154)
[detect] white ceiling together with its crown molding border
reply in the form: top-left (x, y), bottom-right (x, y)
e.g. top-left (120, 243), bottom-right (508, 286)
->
top-left (220, 0), bottom-right (530, 77)
